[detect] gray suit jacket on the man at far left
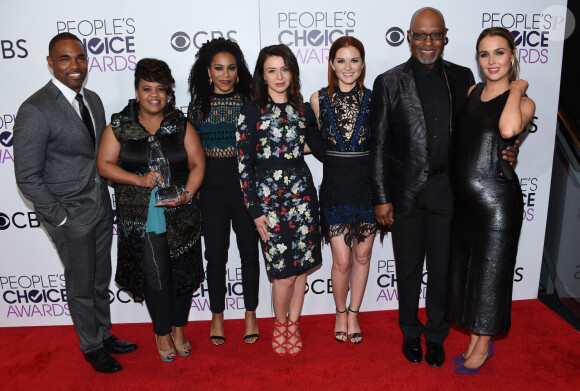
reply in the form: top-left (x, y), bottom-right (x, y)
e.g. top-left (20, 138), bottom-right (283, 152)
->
top-left (13, 81), bottom-right (110, 226)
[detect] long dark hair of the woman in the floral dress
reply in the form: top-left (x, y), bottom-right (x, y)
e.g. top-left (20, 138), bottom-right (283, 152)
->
top-left (252, 45), bottom-right (304, 111)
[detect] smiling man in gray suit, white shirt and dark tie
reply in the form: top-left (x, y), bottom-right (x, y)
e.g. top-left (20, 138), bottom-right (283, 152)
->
top-left (14, 33), bottom-right (137, 373)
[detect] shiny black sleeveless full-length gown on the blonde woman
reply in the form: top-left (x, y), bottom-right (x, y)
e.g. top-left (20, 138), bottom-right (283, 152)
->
top-left (447, 84), bottom-right (523, 335)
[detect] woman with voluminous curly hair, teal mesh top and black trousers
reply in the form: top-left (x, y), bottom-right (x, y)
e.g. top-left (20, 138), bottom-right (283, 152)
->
top-left (187, 38), bottom-right (260, 346)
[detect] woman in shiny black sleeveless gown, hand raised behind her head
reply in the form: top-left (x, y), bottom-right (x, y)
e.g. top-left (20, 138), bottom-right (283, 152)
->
top-left (447, 27), bottom-right (535, 374)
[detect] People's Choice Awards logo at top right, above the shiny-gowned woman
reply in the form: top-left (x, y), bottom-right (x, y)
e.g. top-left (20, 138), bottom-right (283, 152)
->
top-left (481, 7), bottom-right (565, 64)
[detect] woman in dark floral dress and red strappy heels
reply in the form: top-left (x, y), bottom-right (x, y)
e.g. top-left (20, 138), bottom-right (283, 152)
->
top-left (236, 45), bottom-right (324, 355)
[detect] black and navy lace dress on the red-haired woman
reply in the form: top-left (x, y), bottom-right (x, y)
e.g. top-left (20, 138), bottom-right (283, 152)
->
top-left (318, 85), bottom-right (379, 246)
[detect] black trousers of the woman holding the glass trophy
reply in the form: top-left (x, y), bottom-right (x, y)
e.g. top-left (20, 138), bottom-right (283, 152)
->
top-left (143, 232), bottom-right (193, 335)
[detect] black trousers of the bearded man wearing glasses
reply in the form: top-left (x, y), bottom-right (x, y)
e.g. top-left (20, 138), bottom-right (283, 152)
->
top-left (393, 173), bottom-right (453, 342)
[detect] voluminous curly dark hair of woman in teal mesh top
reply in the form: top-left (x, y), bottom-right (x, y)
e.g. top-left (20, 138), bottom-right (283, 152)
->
top-left (189, 38), bottom-right (252, 120)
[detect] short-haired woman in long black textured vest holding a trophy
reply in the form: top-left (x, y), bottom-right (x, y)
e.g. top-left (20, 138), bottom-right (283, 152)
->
top-left (97, 58), bottom-right (205, 362)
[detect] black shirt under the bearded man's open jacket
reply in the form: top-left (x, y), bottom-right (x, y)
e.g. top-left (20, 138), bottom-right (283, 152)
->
top-left (412, 57), bottom-right (451, 169)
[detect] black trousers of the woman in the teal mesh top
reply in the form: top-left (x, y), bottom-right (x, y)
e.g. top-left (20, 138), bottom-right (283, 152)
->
top-left (199, 158), bottom-right (260, 314)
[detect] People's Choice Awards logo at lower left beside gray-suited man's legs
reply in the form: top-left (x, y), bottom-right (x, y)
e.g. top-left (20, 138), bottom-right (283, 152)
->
top-left (0, 274), bottom-right (70, 318)
